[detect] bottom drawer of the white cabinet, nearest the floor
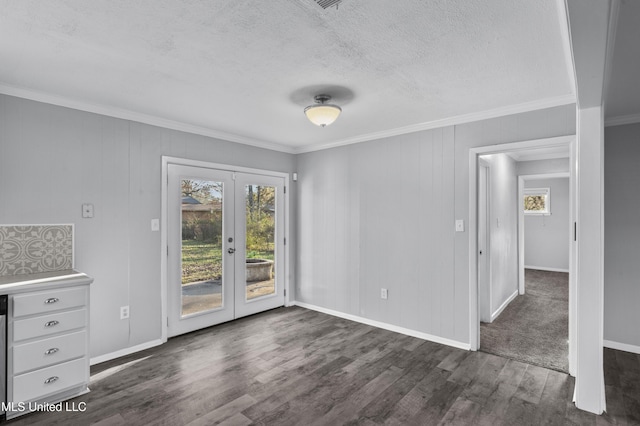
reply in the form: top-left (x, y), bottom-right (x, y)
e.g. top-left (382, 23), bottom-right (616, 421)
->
top-left (12, 358), bottom-right (88, 403)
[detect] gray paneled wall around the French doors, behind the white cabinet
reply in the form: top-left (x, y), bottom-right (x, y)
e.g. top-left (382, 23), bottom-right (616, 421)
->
top-left (0, 95), bottom-right (296, 357)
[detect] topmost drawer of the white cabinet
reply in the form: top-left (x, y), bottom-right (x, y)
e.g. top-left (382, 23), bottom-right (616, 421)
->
top-left (13, 287), bottom-right (87, 318)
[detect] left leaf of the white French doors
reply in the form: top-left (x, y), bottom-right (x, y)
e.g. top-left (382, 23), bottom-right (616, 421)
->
top-left (167, 164), bottom-right (235, 336)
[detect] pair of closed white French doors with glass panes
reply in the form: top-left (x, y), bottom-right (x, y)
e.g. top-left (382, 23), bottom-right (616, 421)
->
top-left (167, 164), bottom-right (284, 336)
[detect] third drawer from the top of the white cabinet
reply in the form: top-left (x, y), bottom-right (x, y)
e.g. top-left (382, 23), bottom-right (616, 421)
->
top-left (13, 331), bottom-right (87, 374)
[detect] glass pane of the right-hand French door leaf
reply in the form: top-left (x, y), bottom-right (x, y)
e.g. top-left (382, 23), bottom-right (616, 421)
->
top-left (245, 185), bottom-right (276, 300)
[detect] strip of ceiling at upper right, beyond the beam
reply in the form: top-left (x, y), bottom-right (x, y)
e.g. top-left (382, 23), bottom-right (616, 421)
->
top-left (605, 0), bottom-right (640, 122)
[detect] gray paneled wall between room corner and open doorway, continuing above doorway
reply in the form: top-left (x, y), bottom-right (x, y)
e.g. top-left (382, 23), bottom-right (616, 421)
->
top-left (296, 105), bottom-right (576, 343)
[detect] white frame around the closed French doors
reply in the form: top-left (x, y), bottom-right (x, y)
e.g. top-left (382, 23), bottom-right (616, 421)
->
top-left (160, 155), bottom-right (291, 343)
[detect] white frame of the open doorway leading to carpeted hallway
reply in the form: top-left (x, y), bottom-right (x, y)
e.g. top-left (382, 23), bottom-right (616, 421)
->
top-left (469, 135), bottom-right (578, 376)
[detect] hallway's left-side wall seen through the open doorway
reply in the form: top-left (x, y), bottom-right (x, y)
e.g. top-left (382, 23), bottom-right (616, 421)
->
top-left (481, 154), bottom-right (518, 321)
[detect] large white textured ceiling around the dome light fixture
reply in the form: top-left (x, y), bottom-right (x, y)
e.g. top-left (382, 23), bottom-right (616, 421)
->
top-left (0, 0), bottom-right (575, 152)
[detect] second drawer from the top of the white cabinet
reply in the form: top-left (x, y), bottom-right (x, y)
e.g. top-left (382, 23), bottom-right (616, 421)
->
top-left (13, 309), bottom-right (87, 342)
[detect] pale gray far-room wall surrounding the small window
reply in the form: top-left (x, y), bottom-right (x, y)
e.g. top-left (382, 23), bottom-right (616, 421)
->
top-left (520, 178), bottom-right (571, 272)
